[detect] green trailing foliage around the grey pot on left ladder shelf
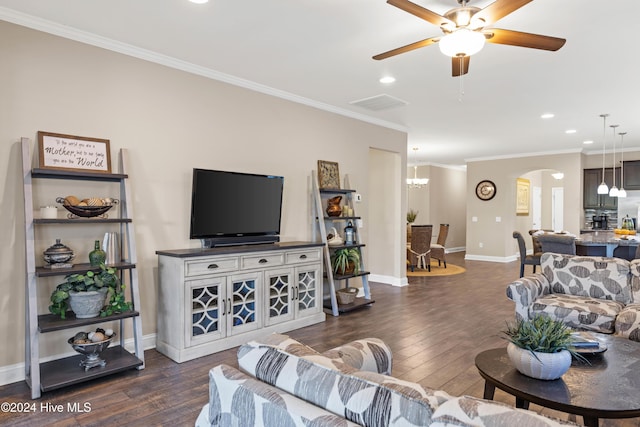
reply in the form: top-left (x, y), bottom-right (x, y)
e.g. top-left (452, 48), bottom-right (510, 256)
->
top-left (49, 264), bottom-right (133, 319)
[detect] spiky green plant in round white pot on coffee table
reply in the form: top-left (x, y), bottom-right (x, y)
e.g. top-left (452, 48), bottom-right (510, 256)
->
top-left (503, 315), bottom-right (585, 380)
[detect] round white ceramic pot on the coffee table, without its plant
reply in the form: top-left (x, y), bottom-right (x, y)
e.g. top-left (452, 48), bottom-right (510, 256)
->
top-left (507, 343), bottom-right (571, 380)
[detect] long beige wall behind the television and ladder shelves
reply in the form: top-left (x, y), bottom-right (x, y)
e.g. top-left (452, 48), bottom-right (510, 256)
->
top-left (0, 22), bottom-right (406, 378)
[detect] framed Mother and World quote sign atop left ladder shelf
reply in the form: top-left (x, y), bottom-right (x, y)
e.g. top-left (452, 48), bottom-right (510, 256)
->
top-left (38, 131), bottom-right (111, 173)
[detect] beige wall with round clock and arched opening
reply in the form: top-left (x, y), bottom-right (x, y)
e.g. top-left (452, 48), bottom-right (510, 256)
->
top-left (466, 153), bottom-right (584, 262)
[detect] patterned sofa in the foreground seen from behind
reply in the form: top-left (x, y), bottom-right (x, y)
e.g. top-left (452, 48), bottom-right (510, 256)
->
top-left (196, 334), bottom-right (576, 427)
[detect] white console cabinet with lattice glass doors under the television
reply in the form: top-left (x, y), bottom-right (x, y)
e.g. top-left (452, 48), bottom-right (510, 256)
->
top-left (156, 242), bottom-right (325, 362)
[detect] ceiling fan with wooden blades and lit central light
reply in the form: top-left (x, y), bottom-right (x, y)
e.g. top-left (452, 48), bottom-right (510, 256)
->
top-left (373, 0), bottom-right (566, 77)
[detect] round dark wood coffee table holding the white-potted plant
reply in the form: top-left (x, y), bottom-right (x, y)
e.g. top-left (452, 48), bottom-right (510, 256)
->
top-left (476, 334), bottom-right (640, 427)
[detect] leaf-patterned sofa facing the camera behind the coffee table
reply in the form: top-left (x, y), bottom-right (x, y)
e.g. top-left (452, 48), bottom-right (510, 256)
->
top-left (507, 253), bottom-right (640, 341)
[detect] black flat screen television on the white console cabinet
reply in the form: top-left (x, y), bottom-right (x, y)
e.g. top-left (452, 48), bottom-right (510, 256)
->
top-left (190, 168), bottom-right (284, 247)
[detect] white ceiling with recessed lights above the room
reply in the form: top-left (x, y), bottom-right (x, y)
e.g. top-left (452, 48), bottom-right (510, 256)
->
top-left (0, 0), bottom-right (640, 165)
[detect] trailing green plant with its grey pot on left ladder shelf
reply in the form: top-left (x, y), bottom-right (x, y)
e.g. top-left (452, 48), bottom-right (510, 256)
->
top-left (49, 264), bottom-right (132, 319)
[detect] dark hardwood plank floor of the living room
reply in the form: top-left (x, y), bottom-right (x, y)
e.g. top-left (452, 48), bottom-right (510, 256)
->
top-left (0, 253), bottom-right (640, 427)
